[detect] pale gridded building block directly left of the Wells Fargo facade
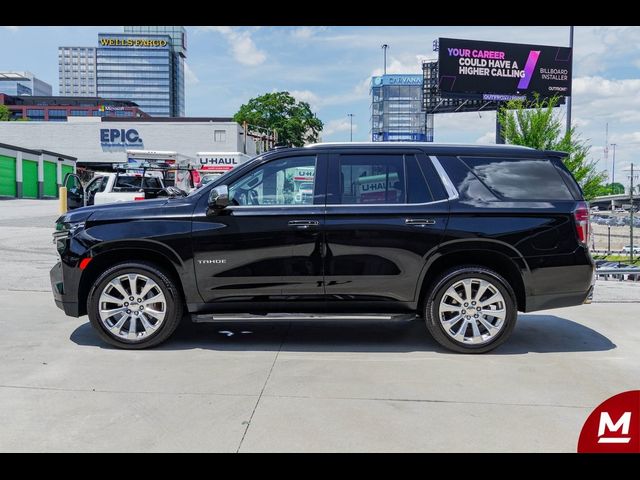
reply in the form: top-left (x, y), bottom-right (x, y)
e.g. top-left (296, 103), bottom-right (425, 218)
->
top-left (58, 47), bottom-right (97, 97)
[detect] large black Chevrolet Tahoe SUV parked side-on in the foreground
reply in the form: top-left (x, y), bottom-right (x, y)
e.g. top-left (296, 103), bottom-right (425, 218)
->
top-left (51, 143), bottom-right (594, 353)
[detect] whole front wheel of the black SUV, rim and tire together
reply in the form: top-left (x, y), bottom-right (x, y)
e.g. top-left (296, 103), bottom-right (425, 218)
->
top-left (87, 262), bottom-right (183, 349)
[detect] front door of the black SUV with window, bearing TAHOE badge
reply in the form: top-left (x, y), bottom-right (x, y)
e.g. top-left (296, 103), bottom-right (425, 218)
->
top-left (193, 154), bottom-right (326, 312)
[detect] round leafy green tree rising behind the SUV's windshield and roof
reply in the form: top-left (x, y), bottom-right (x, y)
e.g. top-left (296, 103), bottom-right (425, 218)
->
top-left (233, 92), bottom-right (323, 147)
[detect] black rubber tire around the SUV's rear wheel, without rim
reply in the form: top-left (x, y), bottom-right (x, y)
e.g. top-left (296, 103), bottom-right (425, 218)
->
top-left (424, 265), bottom-right (518, 353)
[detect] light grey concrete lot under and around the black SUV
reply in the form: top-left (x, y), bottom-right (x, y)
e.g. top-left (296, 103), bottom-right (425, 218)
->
top-left (0, 200), bottom-right (640, 452)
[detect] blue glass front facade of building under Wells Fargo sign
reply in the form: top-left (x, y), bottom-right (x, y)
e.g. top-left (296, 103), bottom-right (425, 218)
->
top-left (96, 33), bottom-right (176, 117)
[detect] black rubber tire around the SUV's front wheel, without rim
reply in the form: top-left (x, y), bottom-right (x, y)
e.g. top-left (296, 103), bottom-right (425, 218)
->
top-left (87, 261), bottom-right (184, 350)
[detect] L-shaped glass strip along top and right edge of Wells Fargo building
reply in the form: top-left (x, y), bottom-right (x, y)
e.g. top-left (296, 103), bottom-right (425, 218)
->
top-left (124, 25), bottom-right (187, 117)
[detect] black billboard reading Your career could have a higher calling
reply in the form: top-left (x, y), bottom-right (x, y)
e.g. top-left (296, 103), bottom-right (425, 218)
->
top-left (438, 38), bottom-right (571, 100)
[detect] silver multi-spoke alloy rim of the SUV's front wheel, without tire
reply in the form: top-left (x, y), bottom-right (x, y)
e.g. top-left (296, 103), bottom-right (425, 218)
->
top-left (98, 273), bottom-right (167, 342)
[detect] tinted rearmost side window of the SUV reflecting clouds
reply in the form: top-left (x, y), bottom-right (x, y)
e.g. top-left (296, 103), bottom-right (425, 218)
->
top-left (460, 157), bottom-right (574, 201)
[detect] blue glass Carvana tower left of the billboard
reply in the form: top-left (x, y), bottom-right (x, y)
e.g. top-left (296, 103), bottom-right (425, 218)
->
top-left (371, 75), bottom-right (433, 142)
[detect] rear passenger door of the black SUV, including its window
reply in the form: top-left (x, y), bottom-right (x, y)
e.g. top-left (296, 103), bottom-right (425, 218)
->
top-left (325, 148), bottom-right (449, 311)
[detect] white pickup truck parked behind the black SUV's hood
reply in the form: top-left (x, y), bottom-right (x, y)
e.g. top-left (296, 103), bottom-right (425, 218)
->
top-left (66, 171), bottom-right (179, 210)
